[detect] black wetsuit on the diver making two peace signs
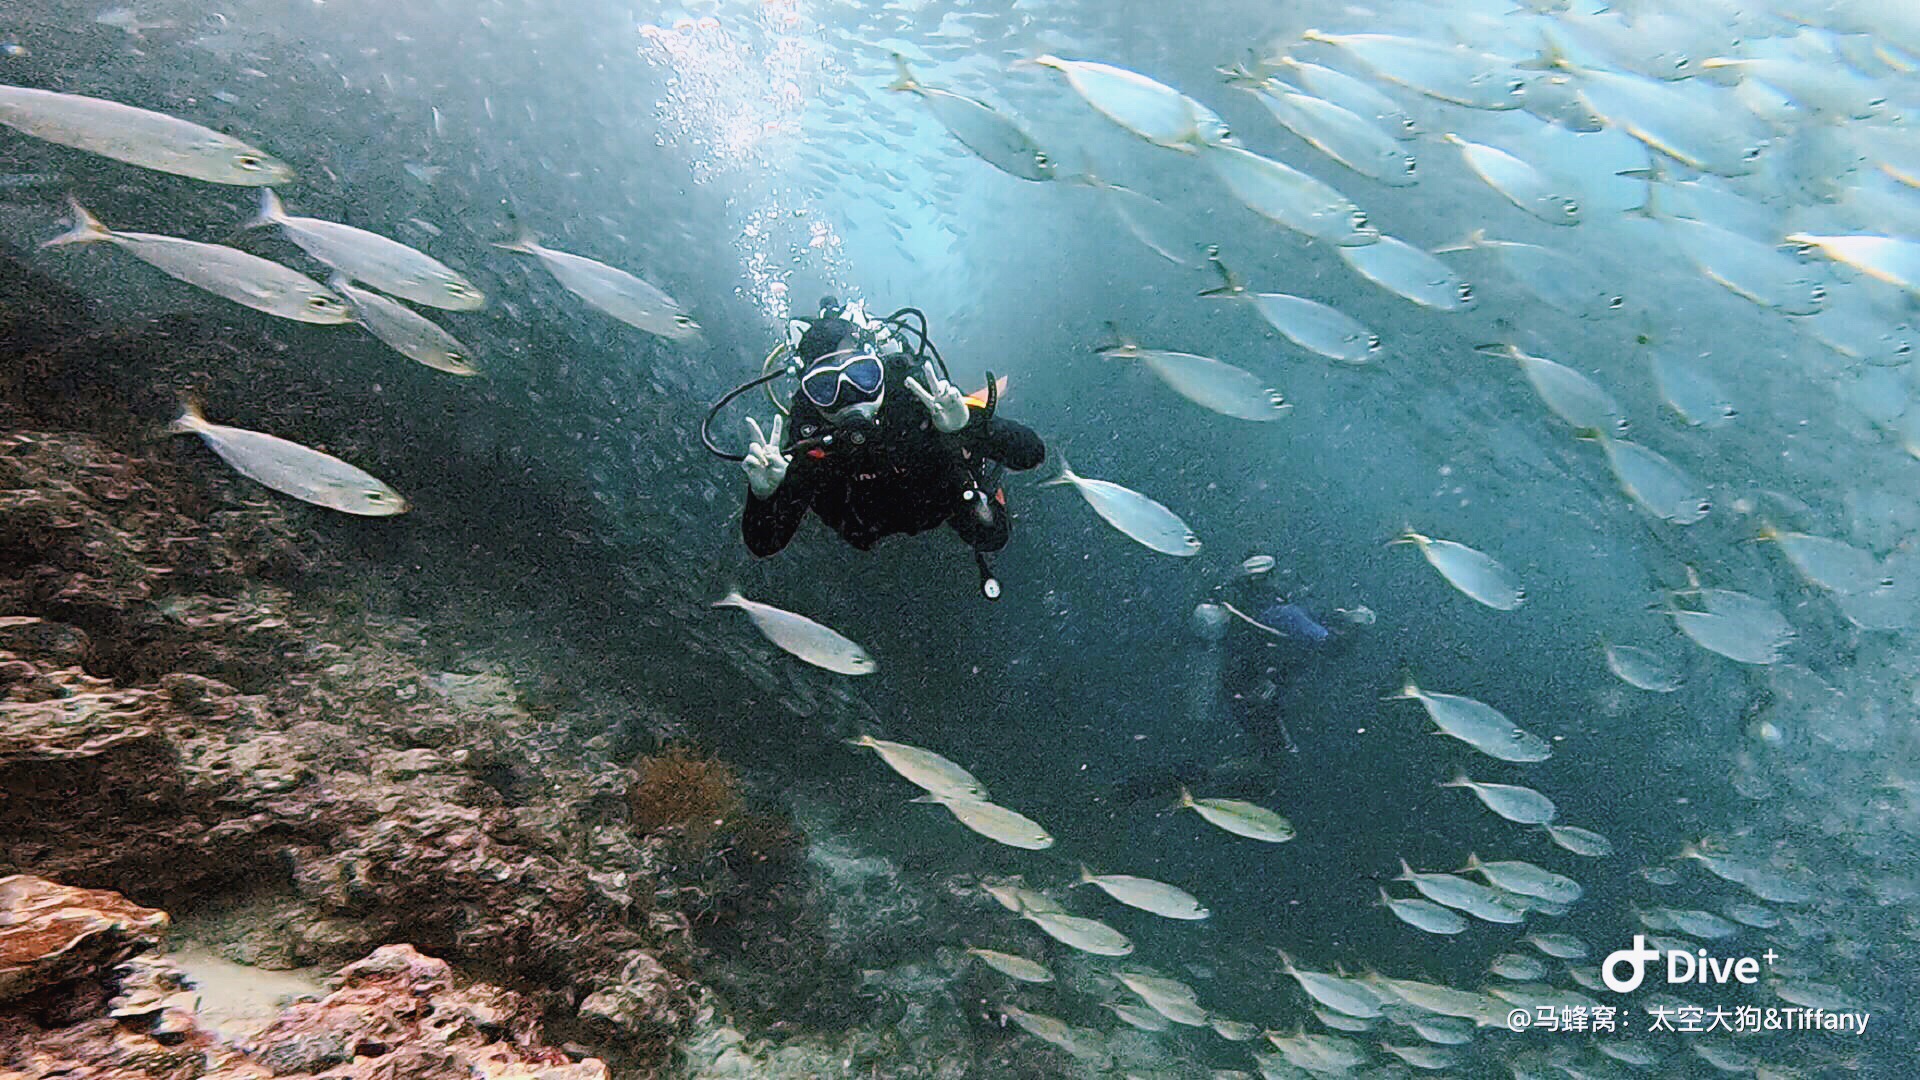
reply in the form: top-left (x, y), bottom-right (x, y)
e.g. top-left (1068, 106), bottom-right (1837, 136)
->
top-left (739, 354), bottom-right (1046, 557)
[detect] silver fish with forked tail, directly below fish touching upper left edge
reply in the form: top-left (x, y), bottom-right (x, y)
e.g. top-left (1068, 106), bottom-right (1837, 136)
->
top-left (40, 198), bottom-right (353, 323)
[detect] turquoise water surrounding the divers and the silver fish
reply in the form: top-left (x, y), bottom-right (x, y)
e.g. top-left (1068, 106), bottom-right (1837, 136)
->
top-left (0, 0), bottom-right (1920, 1076)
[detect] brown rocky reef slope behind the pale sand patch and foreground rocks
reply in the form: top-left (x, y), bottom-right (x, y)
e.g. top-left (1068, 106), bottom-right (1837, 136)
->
top-left (0, 249), bottom-right (701, 1063)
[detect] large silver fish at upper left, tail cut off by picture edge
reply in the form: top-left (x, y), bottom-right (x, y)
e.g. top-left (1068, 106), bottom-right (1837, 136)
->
top-left (0, 86), bottom-right (294, 186)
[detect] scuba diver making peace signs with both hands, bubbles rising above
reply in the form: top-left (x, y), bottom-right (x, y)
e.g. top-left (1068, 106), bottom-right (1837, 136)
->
top-left (701, 296), bottom-right (1046, 600)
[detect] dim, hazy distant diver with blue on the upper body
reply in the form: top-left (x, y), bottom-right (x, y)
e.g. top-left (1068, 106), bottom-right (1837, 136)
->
top-left (1188, 555), bottom-right (1373, 757)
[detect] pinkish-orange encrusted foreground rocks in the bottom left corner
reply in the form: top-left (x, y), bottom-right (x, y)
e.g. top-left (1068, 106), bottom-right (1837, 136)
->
top-left (0, 876), bottom-right (609, 1080)
